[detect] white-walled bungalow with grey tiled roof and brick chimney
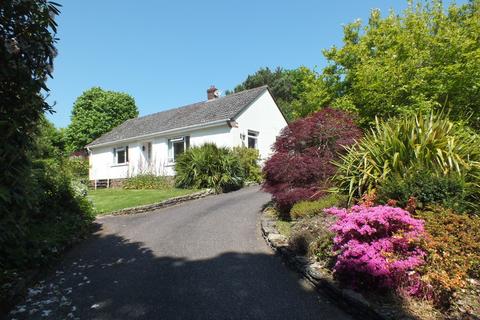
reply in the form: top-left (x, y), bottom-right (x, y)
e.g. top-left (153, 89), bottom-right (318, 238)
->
top-left (86, 86), bottom-right (287, 186)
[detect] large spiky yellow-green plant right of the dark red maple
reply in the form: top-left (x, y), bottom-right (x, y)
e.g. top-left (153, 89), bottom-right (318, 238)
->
top-left (335, 113), bottom-right (480, 210)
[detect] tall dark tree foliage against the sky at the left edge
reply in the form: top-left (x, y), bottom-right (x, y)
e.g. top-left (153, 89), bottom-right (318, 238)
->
top-left (0, 0), bottom-right (59, 269)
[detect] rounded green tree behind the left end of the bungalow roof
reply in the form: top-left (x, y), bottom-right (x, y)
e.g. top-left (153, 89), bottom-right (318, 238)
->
top-left (65, 87), bottom-right (138, 152)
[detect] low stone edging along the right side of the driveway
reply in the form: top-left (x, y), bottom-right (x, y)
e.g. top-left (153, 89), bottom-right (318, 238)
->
top-left (260, 213), bottom-right (391, 320)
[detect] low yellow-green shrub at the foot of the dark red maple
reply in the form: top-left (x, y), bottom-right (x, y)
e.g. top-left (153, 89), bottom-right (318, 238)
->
top-left (290, 193), bottom-right (347, 219)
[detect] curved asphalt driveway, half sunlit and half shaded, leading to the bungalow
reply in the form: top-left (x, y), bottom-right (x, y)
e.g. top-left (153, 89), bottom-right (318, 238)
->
top-left (7, 187), bottom-right (350, 319)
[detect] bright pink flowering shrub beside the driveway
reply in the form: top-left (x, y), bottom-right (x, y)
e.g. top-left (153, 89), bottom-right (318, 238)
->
top-left (325, 205), bottom-right (426, 295)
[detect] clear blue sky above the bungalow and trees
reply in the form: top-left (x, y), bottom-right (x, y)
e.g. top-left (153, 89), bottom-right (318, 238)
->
top-left (48, 0), bottom-right (464, 127)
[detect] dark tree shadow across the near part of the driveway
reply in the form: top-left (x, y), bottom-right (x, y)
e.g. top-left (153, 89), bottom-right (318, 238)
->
top-left (9, 222), bottom-right (349, 319)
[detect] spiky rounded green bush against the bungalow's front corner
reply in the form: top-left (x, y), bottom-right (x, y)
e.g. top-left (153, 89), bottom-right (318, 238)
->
top-left (175, 143), bottom-right (245, 192)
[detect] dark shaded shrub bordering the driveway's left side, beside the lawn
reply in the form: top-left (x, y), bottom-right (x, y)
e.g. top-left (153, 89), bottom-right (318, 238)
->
top-left (0, 159), bottom-right (94, 270)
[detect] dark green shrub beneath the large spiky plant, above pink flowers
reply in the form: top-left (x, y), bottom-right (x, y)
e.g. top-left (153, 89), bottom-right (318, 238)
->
top-left (377, 170), bottom-right (469, 212)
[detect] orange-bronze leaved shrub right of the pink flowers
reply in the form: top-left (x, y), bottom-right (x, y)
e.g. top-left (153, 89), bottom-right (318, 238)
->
top-left (415, 207), bottom-right (480, 306)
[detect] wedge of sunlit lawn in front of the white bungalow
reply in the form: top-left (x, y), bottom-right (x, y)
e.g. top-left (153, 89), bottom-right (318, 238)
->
top-left (88, 188), bottom-right (198, 214)
